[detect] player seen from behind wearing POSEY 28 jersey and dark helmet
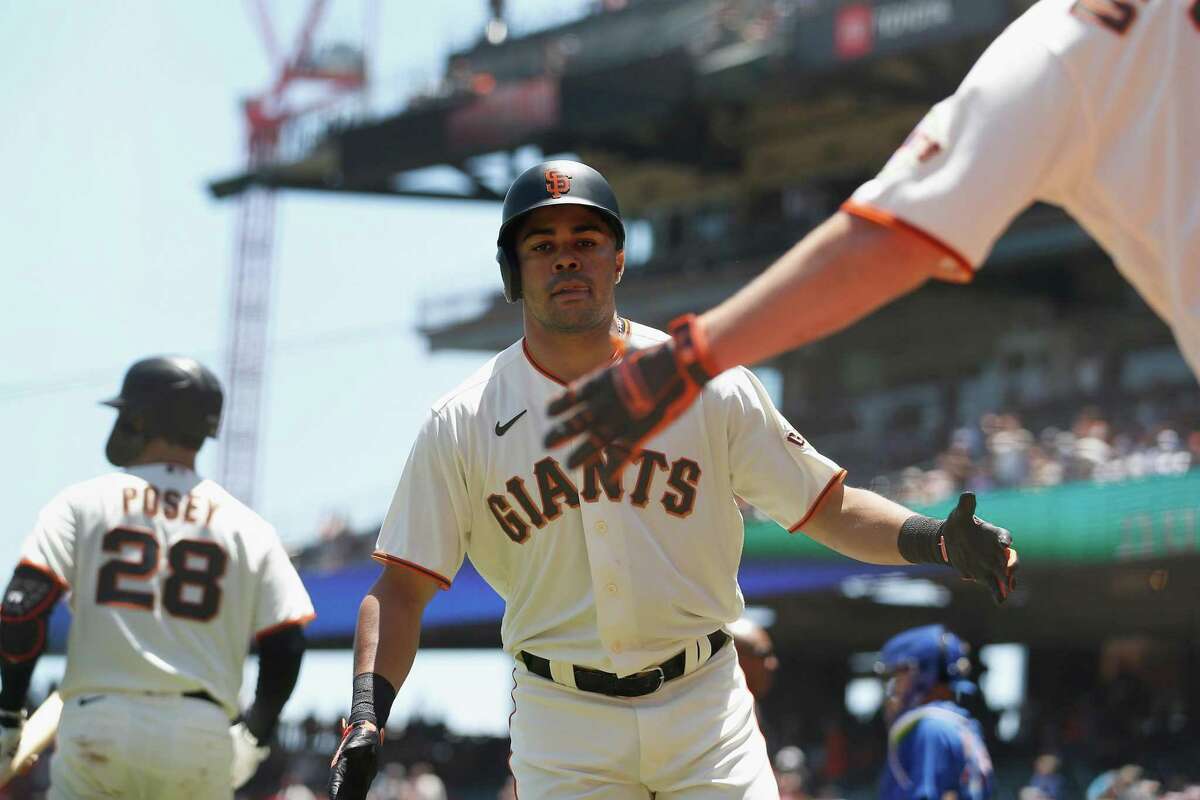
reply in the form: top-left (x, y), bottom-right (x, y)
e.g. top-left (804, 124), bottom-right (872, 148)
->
top-left (0, 356), bottom-right (313, 800)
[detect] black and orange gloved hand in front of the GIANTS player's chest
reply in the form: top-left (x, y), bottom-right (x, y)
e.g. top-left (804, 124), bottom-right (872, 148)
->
top-left (545, 314), bottom-right (715, 471)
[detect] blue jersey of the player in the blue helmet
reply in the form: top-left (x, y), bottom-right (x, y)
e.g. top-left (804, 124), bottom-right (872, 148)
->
top-left (880, 702), bottom-right (995, 800)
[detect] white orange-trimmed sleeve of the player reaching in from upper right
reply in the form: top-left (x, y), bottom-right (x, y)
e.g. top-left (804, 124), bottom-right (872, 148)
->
top-left (842, 19), bottom-right (1086, 275)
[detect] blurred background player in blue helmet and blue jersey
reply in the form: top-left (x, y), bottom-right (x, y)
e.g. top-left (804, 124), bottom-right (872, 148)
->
top-left (876, 625), bottom-right (995, 800)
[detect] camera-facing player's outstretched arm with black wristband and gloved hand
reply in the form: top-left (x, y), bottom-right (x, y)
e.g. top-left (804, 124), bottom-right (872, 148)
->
top-left (803, 485), bottom-right (1018, 603)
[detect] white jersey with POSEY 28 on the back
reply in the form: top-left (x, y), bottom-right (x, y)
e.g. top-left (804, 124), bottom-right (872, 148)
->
top-left (22, 464), bottom-right (313, 716)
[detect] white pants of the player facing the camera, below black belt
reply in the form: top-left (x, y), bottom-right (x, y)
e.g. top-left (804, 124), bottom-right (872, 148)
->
top-left (510, 644), bottom-right (779, 800)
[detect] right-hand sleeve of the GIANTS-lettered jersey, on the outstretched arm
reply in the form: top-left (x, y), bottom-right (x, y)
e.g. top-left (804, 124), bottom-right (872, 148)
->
top-left (714, 367), bottom-right (846, 533)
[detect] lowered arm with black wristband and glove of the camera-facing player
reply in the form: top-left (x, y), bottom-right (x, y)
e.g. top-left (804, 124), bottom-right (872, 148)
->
top-left (329, 565), bottom-right (439, 800)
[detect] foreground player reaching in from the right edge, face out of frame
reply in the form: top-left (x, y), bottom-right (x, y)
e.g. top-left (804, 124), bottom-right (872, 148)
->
top-left (547, 0), bottom-right (1200, 467)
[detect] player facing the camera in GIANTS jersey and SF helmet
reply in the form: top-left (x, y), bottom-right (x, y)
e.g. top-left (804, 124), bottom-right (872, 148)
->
top-left (330, 161), bottom-right (1012, 800)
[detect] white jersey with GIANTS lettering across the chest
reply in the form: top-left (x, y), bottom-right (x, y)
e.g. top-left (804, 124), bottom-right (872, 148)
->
top-left (376, 324), bottom-right (845, 675)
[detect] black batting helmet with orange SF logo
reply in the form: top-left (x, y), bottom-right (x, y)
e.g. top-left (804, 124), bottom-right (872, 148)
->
top-left (496, 160), bottom-right (625, 302)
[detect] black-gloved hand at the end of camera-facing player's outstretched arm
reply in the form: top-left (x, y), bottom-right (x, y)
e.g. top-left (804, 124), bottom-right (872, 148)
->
top-left (941, 492), bottom-right (1018, 604)
